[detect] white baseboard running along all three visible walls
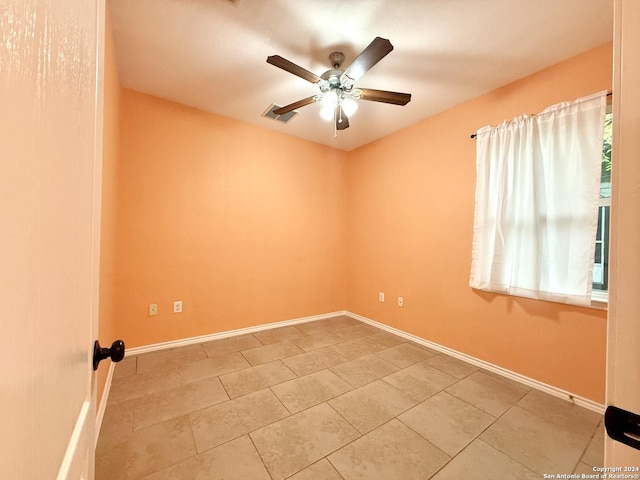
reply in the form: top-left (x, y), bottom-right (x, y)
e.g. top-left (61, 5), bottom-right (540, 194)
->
top-left (96, 310), bottom-right (605, 418)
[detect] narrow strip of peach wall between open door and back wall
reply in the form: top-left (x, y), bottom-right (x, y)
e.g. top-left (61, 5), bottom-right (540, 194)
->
top-left (98, 9), bottom-right (120, 401)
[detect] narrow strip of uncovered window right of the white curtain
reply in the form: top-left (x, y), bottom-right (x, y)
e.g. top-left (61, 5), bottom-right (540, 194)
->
top-left (593, 109), bottom-right (613, 300)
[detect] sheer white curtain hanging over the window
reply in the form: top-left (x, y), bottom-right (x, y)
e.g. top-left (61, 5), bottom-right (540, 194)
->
top-left (469, 92), bottom-right (607, 305)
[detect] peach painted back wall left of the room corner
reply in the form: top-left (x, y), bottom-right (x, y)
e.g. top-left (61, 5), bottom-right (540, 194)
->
top-left (114, 90), bottom-right (347, 347)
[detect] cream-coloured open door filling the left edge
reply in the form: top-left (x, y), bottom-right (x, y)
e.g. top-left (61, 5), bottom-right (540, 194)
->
top-left (0, 0), bottom-right (104, 480)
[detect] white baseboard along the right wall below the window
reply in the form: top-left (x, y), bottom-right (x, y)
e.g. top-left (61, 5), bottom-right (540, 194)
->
top-left (345, 312), bottom-right (604, 415)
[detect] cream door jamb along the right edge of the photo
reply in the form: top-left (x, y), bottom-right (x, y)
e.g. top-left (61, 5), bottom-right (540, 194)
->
top-left (605, 0), bottom-right (640, 466)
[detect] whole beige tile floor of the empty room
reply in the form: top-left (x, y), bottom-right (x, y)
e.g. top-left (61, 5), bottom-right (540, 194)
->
top-left (96, 316), bottom-right (604, 480)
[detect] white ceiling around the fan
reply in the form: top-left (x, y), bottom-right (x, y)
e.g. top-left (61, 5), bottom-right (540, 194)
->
top-left (107, 0), bottom-right (613, 150)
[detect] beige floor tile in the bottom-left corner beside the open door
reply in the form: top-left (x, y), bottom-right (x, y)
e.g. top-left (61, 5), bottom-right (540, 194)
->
top-left (95, 416), bottom-right (196, 480)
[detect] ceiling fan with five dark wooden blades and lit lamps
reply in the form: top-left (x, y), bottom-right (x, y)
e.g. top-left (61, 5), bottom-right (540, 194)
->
top-left (267, 37), bottom-right (411, 136)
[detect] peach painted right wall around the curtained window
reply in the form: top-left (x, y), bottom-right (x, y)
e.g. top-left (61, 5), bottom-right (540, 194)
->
top-left (347, 44), bottom-right (612, 402)
